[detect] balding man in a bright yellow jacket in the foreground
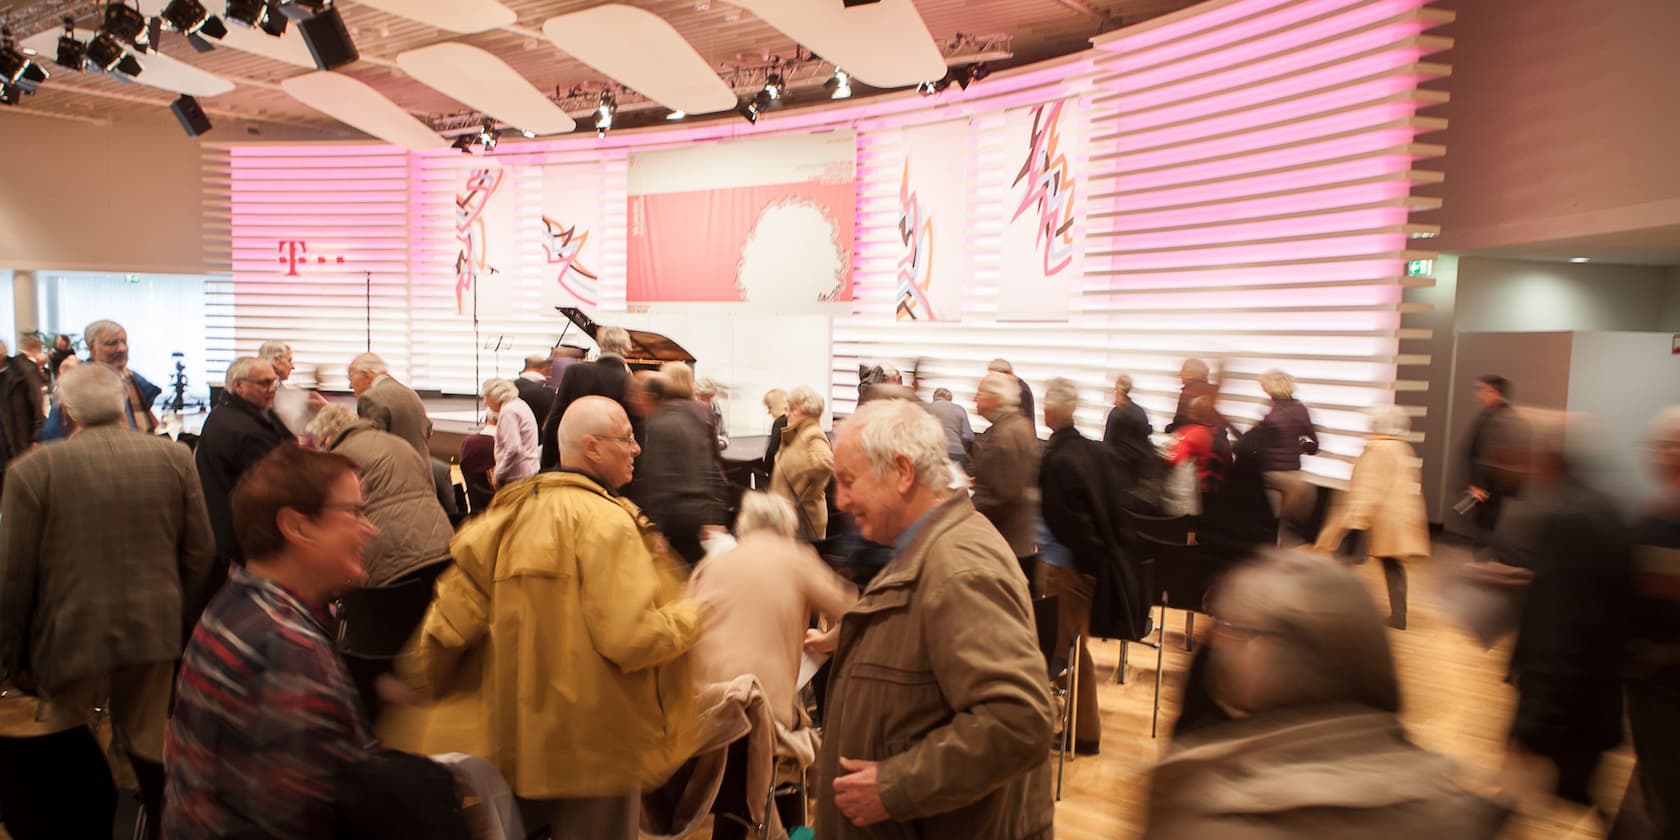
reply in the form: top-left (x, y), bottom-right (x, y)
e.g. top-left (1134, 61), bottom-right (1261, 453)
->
top-left (380, 396), bottom-right (701, 840)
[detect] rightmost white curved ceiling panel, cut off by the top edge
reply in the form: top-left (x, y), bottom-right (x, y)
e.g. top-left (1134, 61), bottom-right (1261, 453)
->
top-left (731, 0), bottom-right (946, 87)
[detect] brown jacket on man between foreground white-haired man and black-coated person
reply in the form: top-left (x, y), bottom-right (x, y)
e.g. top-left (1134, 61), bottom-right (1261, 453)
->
top-left (969, 412), bottom-right (1040, 558)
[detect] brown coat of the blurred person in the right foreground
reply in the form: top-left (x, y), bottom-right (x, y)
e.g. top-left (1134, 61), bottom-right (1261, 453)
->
top-left (1142, 706), bottom-right (1502, 840)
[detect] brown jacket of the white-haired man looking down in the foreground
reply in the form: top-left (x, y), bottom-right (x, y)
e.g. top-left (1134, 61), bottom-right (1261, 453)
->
top-left (816, 494), bottom-right (1055, 840)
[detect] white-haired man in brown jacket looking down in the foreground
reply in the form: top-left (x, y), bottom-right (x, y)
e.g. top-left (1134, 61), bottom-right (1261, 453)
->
top-left (816, 398), bottom-right (1055, 840)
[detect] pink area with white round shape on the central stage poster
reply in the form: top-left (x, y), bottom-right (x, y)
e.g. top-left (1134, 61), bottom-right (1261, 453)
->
top-left (625, 178), bottom-right (857, 309)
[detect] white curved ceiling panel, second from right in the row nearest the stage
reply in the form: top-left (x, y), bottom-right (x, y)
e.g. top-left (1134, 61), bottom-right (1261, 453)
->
top-left (543, 0), bottom-right (735, 114)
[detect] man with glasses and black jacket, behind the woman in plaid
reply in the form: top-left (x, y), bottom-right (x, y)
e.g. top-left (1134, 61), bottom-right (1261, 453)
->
top-left (193, 356), bottom-right (292, 585)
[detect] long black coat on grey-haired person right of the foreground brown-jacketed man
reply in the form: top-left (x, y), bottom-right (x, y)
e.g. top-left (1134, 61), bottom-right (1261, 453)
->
top-left (1038, 427), bottom-right (1151, 638)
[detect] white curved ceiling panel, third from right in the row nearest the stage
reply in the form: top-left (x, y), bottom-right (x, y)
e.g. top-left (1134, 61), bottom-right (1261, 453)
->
top-left (396, 42), bottom-right (578, 134)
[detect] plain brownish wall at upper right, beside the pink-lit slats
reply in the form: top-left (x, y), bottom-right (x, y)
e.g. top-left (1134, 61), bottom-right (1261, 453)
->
top-left (1418, 0), bottom-right (1680, 252)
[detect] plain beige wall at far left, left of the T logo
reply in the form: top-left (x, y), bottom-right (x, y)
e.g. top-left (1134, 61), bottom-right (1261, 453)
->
top-left (0, 111), bottom-right (205, 274)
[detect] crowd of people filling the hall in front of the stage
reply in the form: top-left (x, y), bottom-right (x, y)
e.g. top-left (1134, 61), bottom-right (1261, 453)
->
top-left (0, 321), bottom-right (1680, 840)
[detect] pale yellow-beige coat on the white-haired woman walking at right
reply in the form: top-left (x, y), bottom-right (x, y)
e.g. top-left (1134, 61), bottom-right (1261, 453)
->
top-left (1314, 435), bottom-right (1430, 559)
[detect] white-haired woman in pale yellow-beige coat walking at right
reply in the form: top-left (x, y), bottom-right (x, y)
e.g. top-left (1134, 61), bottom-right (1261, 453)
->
top-left (1314, 405), bottom-right (1430, 630)
